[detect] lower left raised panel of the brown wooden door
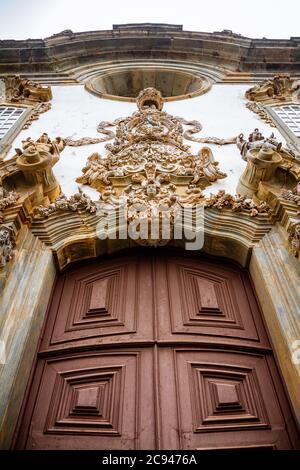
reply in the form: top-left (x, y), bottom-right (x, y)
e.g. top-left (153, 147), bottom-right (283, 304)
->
top-left (20, 349), bottom-right (155, 449)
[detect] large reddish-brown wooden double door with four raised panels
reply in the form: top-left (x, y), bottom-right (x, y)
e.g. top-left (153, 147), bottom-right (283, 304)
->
top-left (16, 250), bottom-right (299, 449)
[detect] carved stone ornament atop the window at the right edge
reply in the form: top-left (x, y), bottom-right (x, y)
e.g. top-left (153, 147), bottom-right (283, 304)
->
top-left (245, 74), bottom-right (299, 103)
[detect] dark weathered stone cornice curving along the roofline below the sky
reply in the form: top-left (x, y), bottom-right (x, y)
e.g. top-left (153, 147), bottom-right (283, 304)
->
top-left (0, 24), bottom-right (300, 74)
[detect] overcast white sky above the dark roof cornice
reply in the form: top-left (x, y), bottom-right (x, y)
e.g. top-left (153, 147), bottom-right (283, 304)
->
top-left (0, 0), bottom-right (300, 39)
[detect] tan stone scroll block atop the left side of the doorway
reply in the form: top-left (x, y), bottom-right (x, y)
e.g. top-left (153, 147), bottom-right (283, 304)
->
top-left (17, 142), bottom-right (60, 202)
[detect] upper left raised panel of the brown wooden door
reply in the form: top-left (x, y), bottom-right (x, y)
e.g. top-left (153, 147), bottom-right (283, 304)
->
top-left (42, 258), bottom-right (153, 350)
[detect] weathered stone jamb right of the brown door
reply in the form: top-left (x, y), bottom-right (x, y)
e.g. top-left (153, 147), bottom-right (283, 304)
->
top-left (250, 222), bottom-right (300, 422)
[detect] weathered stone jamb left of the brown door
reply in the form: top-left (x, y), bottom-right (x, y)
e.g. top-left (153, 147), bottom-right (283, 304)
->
top-left (0, 227), bottom-right (56, 449)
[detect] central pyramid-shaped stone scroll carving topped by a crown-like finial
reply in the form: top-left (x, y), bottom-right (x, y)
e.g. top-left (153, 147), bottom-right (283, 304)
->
top-left (77, 88), bottom-right (226, 197)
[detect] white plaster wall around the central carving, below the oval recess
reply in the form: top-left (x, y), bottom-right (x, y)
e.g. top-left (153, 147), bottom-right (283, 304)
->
top-left (7, 84), bottom-right (283, 199)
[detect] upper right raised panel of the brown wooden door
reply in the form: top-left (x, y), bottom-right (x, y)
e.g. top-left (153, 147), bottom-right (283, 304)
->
top-left (156, 257), bottom-right (269, 348)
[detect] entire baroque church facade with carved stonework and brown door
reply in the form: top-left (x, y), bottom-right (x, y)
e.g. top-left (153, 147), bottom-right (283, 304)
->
top-left (0, 24), bottom-right (300, 450)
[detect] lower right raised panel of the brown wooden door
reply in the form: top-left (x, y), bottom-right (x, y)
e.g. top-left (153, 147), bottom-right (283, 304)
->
top-left (168, 349), bottom-right (296, 449)
